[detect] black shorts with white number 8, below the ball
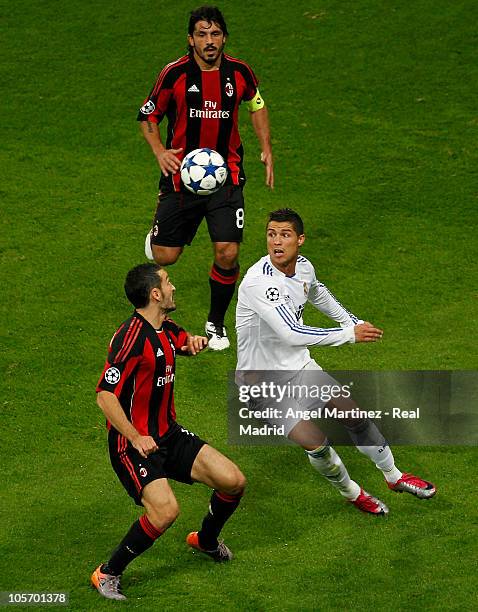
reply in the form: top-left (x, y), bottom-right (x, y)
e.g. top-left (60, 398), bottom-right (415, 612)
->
top-left (151, 185), bottom-right (244, 247)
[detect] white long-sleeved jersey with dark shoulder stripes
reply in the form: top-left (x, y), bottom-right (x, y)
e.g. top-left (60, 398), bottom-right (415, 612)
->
top-left (236, 255), bottom-right (362, 371)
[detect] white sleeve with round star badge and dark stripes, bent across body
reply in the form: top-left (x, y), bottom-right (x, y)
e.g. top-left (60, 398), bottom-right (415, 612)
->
top-left (247, 279), bottom-right (355, 346)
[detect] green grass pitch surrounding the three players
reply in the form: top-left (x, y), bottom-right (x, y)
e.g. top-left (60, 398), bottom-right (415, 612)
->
top-left (0, 0), bottom-right (478, 611)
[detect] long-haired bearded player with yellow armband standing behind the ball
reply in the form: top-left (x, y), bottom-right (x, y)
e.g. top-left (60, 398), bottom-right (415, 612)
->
top-left (138, 6), bottom-right (274, 350)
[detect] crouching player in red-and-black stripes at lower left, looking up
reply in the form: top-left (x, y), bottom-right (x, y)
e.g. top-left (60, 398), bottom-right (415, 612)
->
top-left (91, 263), bottom-right (245, 599)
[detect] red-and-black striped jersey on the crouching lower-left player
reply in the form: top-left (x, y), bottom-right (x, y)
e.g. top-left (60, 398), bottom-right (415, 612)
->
top-left (96, 311), bottom-right (187, 442)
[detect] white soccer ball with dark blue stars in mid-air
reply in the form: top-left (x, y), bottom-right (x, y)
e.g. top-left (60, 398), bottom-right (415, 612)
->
top-left (181, 148), bottom-right (227, 195)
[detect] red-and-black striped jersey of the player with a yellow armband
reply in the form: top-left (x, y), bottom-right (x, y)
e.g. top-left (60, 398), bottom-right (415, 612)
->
top-left (138, 54), bottom-right (258, 191)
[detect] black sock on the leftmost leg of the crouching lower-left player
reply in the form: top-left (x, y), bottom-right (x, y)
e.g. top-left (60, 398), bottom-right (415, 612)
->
top-left (101, 514), bottom-right (163, 576)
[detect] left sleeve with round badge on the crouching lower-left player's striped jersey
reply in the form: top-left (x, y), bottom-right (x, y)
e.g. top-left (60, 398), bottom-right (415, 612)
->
top-left (96, 319), bottom-right (144, 397)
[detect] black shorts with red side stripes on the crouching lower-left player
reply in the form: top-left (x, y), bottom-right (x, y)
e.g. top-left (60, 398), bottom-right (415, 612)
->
top-left (108, 423), bottom-right (206, 506)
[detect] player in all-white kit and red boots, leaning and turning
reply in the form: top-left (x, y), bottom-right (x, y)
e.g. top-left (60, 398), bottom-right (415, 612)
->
top-left (236, 208), bottom-right (436, 515)
